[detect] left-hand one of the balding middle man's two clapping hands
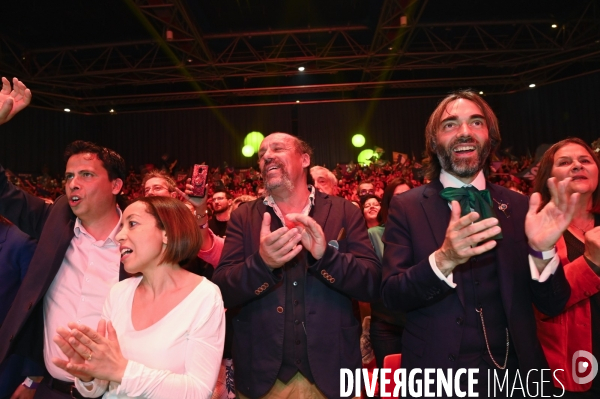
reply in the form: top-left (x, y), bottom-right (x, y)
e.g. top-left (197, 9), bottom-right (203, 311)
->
top-left (258, 212), bottom-right (302, 269)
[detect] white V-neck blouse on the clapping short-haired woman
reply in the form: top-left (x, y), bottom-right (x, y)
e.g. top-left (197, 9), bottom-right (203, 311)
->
top-left (75, 277), bottom-right (225, 399)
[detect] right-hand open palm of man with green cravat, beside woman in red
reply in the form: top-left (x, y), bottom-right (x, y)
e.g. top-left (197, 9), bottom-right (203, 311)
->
top-left (525, 177), bottom-right (579, 251)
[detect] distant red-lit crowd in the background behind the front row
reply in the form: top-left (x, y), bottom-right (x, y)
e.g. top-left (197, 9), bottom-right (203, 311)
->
top-left (6, 155), bottom-right (535, 217)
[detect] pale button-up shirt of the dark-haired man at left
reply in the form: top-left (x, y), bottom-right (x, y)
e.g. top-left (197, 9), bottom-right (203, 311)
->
top-left (44, 208), bottom-right (122, 381)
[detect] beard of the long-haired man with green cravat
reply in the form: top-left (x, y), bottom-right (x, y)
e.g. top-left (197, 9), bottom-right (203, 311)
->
top-left (435, 137), bottom-right (492, 178)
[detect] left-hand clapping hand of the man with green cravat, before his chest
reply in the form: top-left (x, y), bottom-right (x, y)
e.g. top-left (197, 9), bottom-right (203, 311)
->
top-left (435, 201), bottom-right (501, 276)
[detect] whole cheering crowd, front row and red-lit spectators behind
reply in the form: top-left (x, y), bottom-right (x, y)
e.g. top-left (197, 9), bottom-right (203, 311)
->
top-left (0, 78), bottom-right (600, 399)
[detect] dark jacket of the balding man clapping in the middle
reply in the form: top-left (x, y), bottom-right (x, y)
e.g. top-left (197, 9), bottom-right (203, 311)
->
top-left (213, 193), bottom-right (381, 398)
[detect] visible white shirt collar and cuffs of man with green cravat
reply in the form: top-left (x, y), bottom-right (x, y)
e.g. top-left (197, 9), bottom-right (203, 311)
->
top-left (429, 170), bottom-right (560, 288)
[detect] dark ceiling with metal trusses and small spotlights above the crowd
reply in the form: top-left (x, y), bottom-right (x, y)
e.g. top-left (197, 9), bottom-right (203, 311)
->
top-left (0, 0), bottom-right (600, 114)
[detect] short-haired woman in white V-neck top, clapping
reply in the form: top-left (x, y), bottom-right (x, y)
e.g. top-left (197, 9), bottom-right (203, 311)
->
top-left (53, 197), bottom-right (225, 399)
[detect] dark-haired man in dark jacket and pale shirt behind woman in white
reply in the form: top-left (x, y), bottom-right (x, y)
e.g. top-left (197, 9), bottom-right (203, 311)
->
top-left (0, 130), bottom-right (126, 398)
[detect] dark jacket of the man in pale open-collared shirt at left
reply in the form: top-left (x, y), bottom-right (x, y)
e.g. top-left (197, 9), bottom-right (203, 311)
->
top-left (0, 166), bottom-right (126, 364)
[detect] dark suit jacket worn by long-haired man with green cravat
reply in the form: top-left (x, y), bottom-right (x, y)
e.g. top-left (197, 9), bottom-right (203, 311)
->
top-left (382, 179), bottom-right (570, 370)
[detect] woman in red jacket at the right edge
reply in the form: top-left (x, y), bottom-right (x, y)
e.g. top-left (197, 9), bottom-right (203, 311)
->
top-left (534, 138), bottom-right (600, 398)
